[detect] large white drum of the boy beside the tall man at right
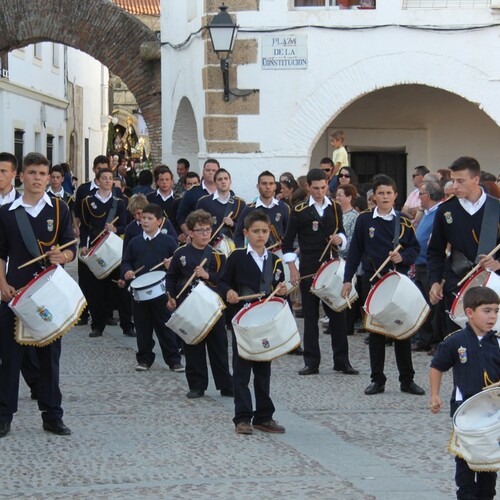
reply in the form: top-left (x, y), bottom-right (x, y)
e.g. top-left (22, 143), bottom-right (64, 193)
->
top-left (363, 271), bottom-right (430, 340)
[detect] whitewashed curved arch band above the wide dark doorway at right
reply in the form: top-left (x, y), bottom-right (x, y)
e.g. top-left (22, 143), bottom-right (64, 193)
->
top-left (284, 52), bottom-right (500, 156)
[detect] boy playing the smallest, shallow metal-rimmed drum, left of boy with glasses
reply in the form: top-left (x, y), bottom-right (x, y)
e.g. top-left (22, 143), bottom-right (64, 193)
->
top-left (120, 203), bottom-right (184, 372)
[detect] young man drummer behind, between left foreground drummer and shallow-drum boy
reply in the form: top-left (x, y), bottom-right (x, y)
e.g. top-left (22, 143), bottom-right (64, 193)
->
top-left (80, 168), bottom-right (135, 337)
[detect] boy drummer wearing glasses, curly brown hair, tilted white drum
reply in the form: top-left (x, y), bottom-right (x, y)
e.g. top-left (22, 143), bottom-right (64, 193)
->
top-left (167, 210), bottom-right (234, 399)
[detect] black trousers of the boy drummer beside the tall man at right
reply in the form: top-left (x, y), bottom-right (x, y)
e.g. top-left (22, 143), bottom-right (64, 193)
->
top-left (362, 275), bottom-right (415, 385)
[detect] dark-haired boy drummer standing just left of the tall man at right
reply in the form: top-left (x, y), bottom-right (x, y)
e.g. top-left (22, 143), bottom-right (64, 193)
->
top-left (341, 175), bottom-right (425, 396)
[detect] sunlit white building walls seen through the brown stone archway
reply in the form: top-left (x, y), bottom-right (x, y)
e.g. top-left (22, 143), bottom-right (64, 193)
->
top-left (0, 42), bottom-right (108, 184)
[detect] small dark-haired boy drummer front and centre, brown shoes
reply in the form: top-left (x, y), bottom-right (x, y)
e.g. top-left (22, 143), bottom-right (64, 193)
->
top-left (219, 210), bottom-right (287, 434)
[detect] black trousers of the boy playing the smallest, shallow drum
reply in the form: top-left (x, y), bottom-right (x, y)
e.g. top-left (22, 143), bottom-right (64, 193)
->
top-left (132, 295), bottom-right (181, 368)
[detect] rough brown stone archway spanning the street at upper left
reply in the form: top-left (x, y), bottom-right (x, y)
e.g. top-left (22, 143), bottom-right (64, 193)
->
top-left (0, 0), bottom-right (161, 161)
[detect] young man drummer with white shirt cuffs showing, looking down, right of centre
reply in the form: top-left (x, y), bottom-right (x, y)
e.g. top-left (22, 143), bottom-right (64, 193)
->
top-left (283, 168), bottom-right (359, 375)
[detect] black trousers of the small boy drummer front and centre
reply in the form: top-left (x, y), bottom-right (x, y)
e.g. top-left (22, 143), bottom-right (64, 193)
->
top-left (233, 334), bottom-right (275, 425)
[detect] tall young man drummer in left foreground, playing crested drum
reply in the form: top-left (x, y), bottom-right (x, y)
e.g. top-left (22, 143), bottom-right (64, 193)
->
top-left (0, 153), bottom-right (76, 437)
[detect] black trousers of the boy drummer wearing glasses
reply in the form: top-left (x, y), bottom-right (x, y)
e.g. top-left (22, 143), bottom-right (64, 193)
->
top-left (184, 318), bottom-right (233, 391)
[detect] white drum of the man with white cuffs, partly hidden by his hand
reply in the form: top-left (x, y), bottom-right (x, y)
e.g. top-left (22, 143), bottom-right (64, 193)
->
top-left (311, 257), bottom-right (358, 312)
